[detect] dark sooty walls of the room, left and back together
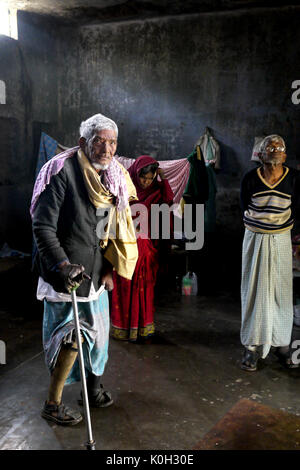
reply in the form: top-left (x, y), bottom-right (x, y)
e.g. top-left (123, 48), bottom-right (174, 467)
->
top-left (0, 7), bottom-right (300, 253)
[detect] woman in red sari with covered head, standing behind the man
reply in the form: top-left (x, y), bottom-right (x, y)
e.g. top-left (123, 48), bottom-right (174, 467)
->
top-left (111, 155), bottom-right (174, 342)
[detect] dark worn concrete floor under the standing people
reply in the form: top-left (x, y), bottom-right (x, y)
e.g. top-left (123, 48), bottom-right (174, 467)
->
top-left (0, 292), bottom-right (300, 450)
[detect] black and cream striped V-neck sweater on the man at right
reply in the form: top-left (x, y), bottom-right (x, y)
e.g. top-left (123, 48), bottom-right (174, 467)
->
top-left (241, 166), bottom-right (300, 233)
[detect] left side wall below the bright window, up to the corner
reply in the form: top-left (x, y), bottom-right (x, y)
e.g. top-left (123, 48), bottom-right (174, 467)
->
top-left (0, 13), bottom-right (58, 252)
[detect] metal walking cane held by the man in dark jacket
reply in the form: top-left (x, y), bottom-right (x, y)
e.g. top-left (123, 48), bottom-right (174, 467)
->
top-left (71, 287), bottom-right (96, 450)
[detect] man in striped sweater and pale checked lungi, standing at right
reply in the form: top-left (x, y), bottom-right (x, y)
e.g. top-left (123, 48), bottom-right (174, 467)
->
top-left (241, 134), bottom-right (300, 371)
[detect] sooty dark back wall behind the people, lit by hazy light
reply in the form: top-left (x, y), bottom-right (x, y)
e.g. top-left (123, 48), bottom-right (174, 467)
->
top-left (59, 7), bottom-right (300, 231)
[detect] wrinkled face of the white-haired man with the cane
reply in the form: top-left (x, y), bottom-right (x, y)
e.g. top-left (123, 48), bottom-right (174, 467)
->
top-left (86, 129), bottom-right (117, 170)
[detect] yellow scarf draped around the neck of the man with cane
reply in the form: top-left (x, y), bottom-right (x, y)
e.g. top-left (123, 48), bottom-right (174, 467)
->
top-left (77, 149), bottom-right (138, 279)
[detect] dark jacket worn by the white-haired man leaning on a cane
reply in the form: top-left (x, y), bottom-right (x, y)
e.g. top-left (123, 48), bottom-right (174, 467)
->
top-left (32, 153), bottom-right (103, 297)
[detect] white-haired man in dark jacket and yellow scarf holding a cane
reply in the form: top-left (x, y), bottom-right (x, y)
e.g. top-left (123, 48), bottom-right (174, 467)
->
top-left (31, 114), bottom-right (138, 425)
